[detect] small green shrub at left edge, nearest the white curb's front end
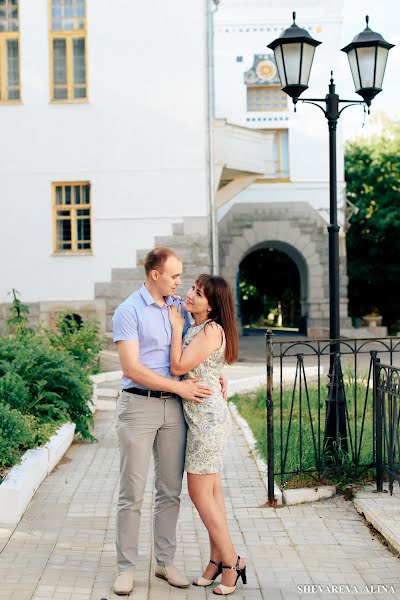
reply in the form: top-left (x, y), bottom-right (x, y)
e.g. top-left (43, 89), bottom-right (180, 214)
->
top-left (0, 404), bottom-right (34, 467)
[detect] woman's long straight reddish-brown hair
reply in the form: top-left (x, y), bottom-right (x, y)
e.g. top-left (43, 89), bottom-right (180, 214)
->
top-left (196, 273), bottom-right (239, 364)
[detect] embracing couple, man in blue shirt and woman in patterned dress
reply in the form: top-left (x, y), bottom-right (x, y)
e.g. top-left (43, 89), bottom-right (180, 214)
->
top-left (113, 247), bottom-right (246, 595)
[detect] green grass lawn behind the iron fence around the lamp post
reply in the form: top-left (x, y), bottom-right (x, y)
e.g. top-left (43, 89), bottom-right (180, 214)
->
top-left (230, 377), bottom-right (373, 487)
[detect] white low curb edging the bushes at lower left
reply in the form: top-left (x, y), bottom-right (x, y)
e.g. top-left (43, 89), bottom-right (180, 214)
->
top-left (0, 423), bottom-right (75, 526)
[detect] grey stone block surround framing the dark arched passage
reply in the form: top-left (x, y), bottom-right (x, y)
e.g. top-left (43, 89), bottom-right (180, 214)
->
top-left (219, 202), bottom-right (349, 336)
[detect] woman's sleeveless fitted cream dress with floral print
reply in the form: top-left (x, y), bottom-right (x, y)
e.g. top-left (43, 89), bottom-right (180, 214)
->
top-left (183, 321), bottom-right (231, 475)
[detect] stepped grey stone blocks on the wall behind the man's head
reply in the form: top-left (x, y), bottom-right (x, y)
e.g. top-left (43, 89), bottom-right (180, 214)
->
top-left (95, 219), bottom-right (210, 350)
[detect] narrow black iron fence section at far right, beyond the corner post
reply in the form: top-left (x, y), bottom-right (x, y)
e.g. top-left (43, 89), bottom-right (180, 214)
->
top-left (375, 358), bottom-right (400, 495)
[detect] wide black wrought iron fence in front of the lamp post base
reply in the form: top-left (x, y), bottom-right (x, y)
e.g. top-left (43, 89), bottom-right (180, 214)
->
top-left (266, 331), bottom-right (400, 504)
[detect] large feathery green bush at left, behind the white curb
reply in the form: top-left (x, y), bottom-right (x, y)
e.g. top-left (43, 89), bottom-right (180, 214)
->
top-left (0, 334), bottom-right (94, 440)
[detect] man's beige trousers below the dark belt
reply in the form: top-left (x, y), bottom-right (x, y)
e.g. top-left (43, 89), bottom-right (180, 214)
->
top-left (116, 392), bottom-right (186, 570)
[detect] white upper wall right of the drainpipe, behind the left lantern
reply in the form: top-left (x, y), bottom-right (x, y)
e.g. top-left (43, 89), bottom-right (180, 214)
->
top-left (215, 0), bottom-right (344, 190)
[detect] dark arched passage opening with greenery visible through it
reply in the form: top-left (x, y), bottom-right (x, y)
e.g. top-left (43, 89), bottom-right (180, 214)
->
top-left (238, 240), bottom-right (308, 331)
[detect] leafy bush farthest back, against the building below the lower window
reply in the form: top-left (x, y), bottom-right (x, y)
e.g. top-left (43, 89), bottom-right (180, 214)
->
top-left (46, 312), bottom-right (103, 373)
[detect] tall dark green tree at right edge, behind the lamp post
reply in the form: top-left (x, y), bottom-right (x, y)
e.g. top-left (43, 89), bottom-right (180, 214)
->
top-left (345, 118), bottom-right (400, 327)
